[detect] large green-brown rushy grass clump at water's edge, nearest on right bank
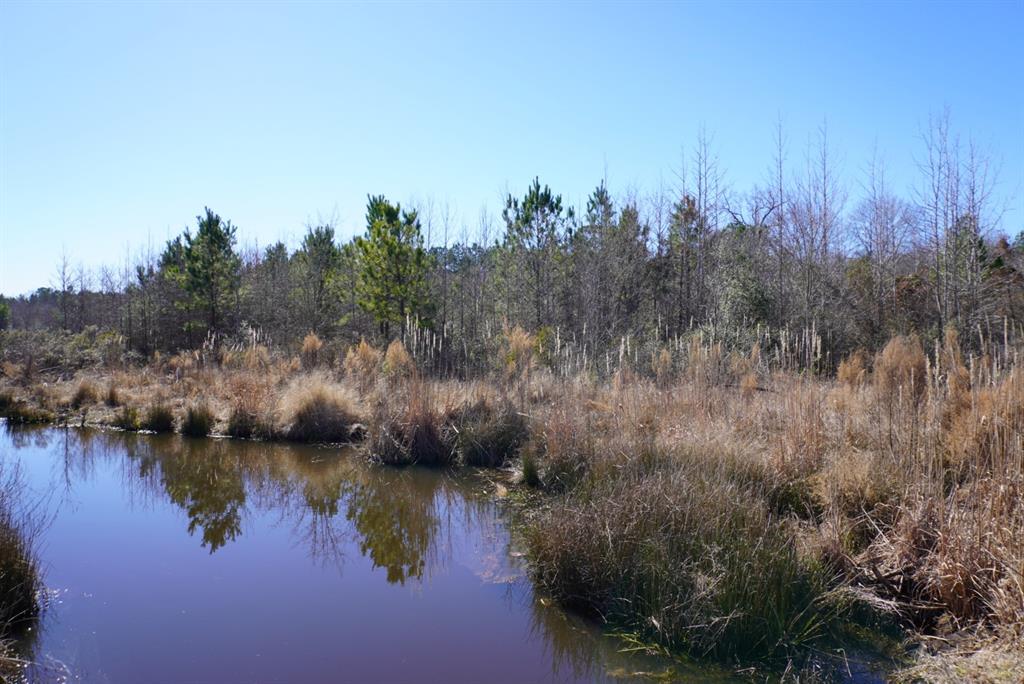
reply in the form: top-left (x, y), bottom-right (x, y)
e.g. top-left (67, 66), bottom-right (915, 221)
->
top-left (527, 455), bottom-right (834, 659)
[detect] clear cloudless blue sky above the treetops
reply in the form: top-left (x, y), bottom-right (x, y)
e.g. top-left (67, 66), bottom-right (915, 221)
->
top-left (0, 0), bottom-right (1024, 295)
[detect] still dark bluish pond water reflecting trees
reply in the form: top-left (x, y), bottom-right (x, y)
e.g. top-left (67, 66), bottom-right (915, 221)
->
top-left (0, 429), bottom-right (722, 684)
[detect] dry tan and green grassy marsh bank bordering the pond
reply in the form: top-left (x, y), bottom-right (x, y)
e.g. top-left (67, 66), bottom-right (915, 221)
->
top-left (0, 330), bottom-right (1024, 681)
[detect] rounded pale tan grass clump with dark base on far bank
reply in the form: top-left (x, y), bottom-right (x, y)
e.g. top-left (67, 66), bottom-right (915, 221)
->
top-left (279, 375), bottom-right (358, 442)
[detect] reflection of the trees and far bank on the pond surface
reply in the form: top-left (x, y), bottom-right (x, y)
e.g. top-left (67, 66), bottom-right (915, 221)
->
top-left (12, 430), bottom-right (478, 584)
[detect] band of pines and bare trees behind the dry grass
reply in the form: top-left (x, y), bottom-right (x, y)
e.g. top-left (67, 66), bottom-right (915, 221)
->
top-left (0, 117), bottom-right (1024, 373)
